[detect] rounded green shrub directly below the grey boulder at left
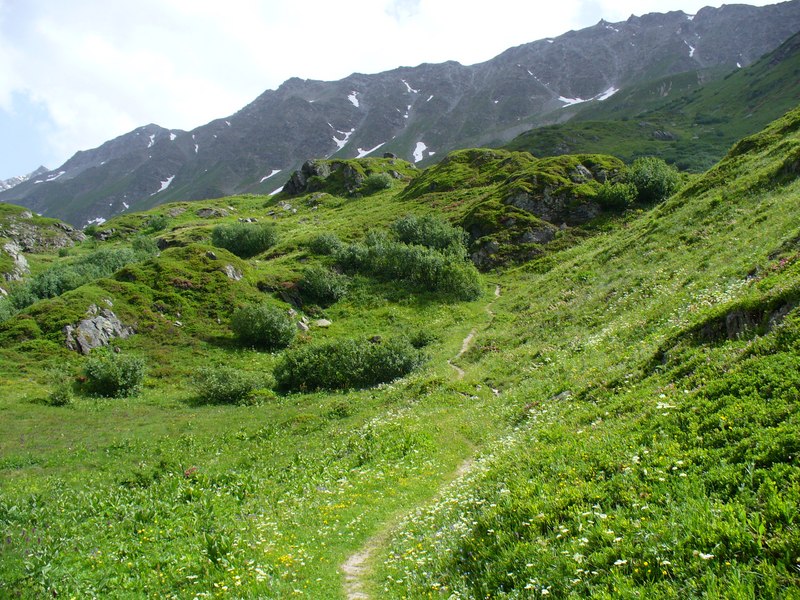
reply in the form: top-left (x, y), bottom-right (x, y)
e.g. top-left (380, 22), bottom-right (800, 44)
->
top-left (84, 348), bottom-right (145, 397)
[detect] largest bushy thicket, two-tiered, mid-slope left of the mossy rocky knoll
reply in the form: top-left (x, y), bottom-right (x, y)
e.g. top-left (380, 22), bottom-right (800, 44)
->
top-left (336, 216), bottom-right (481, 300)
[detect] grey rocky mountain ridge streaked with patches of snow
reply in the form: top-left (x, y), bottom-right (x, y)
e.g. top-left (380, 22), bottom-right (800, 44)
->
top-left (0, 0), bottom-right (800, 225)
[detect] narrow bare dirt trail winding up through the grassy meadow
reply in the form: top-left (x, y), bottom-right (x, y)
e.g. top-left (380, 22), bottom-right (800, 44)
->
top-left (341, 285), bottom-right (500, 600)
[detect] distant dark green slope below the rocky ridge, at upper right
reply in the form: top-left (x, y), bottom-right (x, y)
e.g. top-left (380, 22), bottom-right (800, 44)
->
top-left (506, 34), bottom-right (800, 172)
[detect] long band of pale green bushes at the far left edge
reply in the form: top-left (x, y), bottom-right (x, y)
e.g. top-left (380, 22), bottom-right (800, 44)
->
top-left (0, 238), bottom-right (158, 320)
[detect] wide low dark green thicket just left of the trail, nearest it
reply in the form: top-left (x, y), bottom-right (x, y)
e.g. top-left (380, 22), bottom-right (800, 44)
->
top-left (274, 339), bottom-right (422, 391)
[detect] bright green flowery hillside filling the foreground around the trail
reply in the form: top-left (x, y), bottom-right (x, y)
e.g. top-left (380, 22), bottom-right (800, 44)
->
top-left (0, 109), bottom-right (800, 598)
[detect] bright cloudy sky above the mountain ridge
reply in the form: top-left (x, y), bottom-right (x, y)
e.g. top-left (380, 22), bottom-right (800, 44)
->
top-left (0, 0), bottom-right (772, 179)
